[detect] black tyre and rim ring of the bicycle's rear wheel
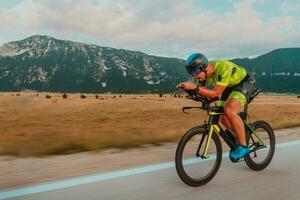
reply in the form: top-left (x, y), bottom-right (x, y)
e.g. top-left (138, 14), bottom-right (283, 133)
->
top-left (244, 121), bottom-right (275, 171)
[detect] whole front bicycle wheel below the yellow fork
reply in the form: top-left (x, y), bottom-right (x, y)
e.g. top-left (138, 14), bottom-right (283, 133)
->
top-left (175, 127), bottom-right (222, 187)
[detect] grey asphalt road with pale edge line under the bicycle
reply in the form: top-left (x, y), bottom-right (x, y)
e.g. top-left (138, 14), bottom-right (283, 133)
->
top-left (0, 141), bottom-right (300, 200)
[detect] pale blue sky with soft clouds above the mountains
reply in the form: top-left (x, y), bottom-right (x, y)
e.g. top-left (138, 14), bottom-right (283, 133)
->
top-left (0, 0), bottom-right (300, 59)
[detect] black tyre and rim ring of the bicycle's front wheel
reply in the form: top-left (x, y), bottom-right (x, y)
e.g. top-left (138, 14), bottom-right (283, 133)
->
top-left (175, 126), bottom-right (222, 187)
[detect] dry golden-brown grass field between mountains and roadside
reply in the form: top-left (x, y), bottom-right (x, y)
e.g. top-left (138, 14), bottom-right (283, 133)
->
top-left (0, 93), bottom-right (300, 157)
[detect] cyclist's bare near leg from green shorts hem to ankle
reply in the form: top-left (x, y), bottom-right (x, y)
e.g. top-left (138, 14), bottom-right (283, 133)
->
top-left (224, 91), bottom-right (247, 146)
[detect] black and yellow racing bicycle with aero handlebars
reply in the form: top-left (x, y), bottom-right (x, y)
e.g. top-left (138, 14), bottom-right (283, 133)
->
top-left (175, 89), bottom-right (275, 187)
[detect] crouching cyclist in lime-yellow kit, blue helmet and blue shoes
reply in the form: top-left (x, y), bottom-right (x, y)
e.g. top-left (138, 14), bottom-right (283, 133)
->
top-left (177, 53), bottom-right (255, 159)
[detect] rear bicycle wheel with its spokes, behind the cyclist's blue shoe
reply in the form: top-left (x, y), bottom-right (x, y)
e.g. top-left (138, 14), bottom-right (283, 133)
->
top-left (244, 121), bottom-right (275, 171)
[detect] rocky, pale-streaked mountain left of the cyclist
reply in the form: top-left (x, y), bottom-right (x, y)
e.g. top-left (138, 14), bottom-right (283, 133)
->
top-left (0, 35), bottom-right (187, 92)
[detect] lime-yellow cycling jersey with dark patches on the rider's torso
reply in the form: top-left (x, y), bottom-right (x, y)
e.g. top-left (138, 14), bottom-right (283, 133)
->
top-left (207, 60), bottom-right (247, 87)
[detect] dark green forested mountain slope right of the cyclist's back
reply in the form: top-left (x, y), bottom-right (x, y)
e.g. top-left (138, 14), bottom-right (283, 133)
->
top-left (232, 48), bottom-right (300, 93)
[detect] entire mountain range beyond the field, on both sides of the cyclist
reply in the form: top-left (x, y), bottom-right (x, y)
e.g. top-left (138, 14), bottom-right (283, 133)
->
top-left (0, 35), bottom-right (300, 93)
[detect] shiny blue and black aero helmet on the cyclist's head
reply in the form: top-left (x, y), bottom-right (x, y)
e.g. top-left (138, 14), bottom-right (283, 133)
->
top-left (185, 53), bottom-right (208, 75)
